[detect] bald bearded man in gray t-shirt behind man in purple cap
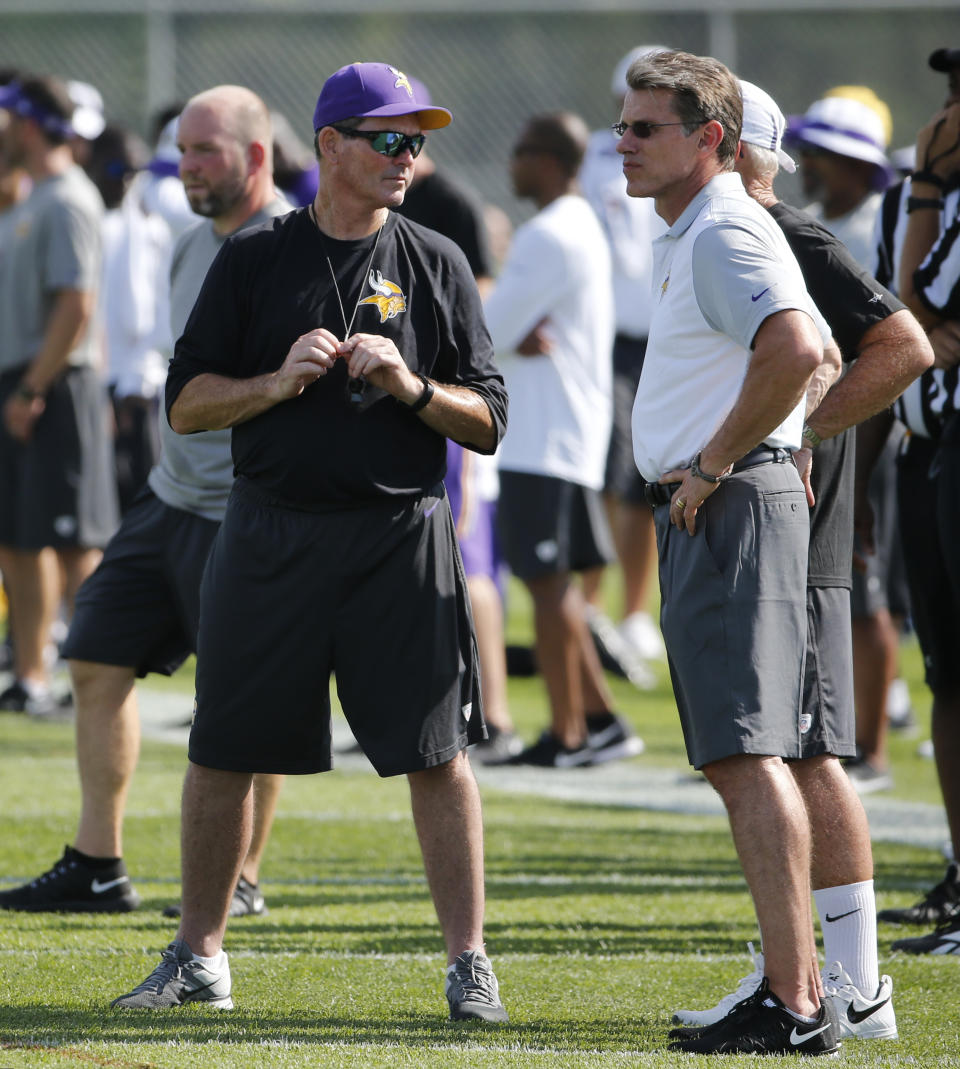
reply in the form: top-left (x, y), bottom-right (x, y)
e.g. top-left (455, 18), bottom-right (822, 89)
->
top-left (0, 86), bottom-right (290, 916)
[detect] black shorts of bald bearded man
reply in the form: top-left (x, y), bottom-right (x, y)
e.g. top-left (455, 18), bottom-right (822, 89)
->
top-left (63, 489), bottom-right (219, 676)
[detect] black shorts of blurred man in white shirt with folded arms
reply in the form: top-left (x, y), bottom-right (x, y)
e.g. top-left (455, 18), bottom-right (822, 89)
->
top-left (497, 471), bottom-right (614, 579)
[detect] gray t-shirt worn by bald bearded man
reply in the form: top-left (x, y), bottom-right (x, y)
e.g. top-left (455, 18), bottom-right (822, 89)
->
top-left (146, 197), bottom-right (290, 523)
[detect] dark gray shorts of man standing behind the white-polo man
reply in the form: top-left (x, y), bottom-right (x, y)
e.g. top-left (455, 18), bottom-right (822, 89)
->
top-left (800, 587), bottom-right (856, 757)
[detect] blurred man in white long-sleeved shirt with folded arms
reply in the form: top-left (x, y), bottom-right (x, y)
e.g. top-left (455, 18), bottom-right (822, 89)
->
top-left (485, 112), bottom-right (641, 768)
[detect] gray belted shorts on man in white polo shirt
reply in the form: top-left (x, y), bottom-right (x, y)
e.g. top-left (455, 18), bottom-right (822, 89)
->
top-left (653, 463), bottom-right (809, 769)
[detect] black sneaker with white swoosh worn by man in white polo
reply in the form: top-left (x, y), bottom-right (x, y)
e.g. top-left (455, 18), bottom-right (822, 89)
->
top-left (668, 976), bottom-right (840, 1055)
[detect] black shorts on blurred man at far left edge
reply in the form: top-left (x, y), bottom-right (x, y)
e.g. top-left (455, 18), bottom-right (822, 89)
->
top-left (0, 368), bottom-right (120, 551)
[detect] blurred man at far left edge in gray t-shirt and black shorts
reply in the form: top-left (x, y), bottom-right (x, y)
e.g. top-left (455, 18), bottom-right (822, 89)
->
top-left (0, 71), bottom-right (118, 715)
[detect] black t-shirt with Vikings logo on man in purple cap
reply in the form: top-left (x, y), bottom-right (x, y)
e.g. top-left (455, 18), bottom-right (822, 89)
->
top-left (166, 208), bottom-right (507, 509)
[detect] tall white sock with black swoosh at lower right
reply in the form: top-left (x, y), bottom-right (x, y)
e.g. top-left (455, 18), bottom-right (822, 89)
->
top-left (814, 880), bottom-right (880, 996)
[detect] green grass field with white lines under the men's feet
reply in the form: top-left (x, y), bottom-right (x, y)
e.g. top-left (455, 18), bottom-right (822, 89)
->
top-left (0, 590), bottom-right (960, 1069)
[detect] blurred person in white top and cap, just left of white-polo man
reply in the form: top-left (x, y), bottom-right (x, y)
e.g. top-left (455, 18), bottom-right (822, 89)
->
top-left (579, 45), bottom-right (666, 687)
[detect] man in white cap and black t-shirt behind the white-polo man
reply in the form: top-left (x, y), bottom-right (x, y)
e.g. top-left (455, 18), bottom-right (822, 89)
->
top-left (671, 80), bottom-right (933, 1038)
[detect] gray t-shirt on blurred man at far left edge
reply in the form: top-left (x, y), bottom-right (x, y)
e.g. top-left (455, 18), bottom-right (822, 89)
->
top-left (0, 166), bottom-right (104, 371)
